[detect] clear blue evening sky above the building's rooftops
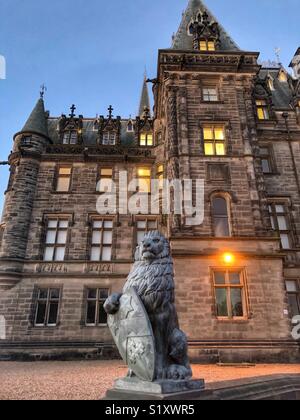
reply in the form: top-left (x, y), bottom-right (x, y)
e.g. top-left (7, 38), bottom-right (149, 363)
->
top-left (0, 0), bottom-right (300, 211)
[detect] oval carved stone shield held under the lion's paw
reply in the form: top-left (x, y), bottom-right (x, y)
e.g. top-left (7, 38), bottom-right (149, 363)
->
top-left (108, 288), bottom-right (155, 382)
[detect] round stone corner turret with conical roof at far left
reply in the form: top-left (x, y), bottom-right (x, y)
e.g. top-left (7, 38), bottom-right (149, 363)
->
top-left (0, 98), bottom-right (50, 290)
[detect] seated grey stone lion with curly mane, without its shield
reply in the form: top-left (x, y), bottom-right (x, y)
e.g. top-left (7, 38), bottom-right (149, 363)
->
top-left (104, 231), bottom-right (192, 380)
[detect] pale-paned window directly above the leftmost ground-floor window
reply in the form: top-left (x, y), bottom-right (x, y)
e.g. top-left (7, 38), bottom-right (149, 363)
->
top-left (44, 218), bottom-right (69, 261)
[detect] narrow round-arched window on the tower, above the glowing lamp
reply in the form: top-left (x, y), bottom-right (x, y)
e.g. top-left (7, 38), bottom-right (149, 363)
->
top-left (212, 196), bottom-right (231, 238)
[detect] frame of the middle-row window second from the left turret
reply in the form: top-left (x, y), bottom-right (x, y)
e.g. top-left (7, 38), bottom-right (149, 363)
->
top-left (88, 216), bottom-right (115, 264)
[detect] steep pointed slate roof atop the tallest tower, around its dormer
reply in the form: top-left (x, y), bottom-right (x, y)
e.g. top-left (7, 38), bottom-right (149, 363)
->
top-left (172, 0), bottom-right (239, 51)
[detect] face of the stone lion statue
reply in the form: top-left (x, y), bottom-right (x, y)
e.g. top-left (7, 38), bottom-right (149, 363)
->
top-left (136, 231), bottom-right (170, 262)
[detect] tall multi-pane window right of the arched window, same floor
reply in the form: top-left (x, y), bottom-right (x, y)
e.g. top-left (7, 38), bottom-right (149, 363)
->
top-left (269, 203), bottom-right (292, 249)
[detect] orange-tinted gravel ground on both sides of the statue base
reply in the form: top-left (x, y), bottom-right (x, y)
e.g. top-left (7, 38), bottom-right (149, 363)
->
top-left (0, 361), bottom-right (300, 400)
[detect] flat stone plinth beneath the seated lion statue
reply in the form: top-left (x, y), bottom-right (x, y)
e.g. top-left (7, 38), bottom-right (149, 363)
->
top-left (105, 377), bottom-right (205, 401)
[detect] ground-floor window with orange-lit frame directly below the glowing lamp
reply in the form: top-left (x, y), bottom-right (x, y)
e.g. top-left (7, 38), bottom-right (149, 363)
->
top-left (213, 269), bottom-right (247, 319)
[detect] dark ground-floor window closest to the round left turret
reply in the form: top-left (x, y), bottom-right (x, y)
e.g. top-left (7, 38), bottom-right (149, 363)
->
top-left (34, 288), bottom-right (61, 327)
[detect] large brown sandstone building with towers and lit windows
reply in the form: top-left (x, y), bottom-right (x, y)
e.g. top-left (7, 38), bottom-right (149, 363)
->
top-left (0, 0), bottom-right (300, 362)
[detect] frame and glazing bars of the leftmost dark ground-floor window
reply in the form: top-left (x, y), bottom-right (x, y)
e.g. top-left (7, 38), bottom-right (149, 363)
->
top-left (33, 286), bottom-right (63, 328)
